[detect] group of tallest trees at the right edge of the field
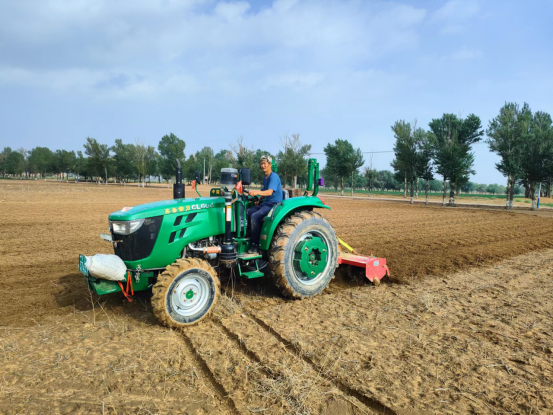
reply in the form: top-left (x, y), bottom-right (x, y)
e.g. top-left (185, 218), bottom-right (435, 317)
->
top-left (391, 103), bottom-right (553, 209)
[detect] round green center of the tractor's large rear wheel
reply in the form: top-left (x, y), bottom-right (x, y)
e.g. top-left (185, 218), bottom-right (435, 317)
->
top-left (293, 231), bottom-right (329, 285)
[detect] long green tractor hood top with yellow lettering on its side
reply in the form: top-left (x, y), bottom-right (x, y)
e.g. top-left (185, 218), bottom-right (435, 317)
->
top-left (109, 197), bottom-right (225, 220)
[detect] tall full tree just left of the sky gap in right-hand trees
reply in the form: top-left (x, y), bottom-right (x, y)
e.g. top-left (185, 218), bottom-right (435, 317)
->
top-left (429, 114), bottom-right (484, 206)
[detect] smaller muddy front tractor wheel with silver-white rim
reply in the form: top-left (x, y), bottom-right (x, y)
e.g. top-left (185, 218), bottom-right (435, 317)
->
top-left (151, 258), bottom-right (220, 328)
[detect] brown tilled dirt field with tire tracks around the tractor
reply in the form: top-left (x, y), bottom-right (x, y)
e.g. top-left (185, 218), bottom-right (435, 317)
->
top-left (0, 181), bottom-right (553, 414)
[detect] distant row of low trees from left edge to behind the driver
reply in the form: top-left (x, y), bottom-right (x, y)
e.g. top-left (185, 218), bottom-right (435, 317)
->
top-left (0, 133), bottom-right (311, 186)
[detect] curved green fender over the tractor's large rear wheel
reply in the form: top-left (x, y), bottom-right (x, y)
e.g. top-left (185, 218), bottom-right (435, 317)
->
top-left (259, 196), bottom-right (330, 250)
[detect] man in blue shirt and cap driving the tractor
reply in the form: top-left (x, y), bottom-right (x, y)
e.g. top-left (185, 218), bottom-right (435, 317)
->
top-left (246, 155), bottom-right (282, 254)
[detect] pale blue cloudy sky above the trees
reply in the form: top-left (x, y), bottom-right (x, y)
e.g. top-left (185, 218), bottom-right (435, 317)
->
top-left (0, 0), bottom-right (553, 184)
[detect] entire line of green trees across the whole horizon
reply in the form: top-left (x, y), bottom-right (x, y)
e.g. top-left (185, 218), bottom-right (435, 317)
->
top-left (0, 103), bottom-right (553, 208)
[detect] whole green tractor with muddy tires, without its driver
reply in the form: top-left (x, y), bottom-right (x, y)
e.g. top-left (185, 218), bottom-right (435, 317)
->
top-left (79, 159), bottom-right (387, 327)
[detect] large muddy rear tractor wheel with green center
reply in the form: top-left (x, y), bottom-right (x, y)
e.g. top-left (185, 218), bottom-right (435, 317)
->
top-left (269, 211), bottom-right (338, 298)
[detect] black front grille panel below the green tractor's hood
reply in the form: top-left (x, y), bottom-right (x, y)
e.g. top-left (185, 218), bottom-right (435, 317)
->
top-left (111, 216), bottom-right (163, 261)
